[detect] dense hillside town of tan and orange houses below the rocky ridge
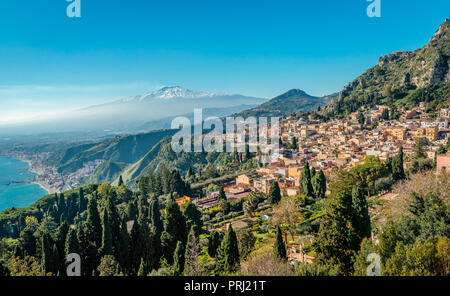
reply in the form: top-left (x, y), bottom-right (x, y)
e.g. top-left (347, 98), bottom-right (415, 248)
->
top-left (190, 105), bottom-right (450, 209)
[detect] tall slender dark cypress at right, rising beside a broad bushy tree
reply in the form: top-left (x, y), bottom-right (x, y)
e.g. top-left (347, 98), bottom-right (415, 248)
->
top-left (352, 185), bottom-right (371, 245)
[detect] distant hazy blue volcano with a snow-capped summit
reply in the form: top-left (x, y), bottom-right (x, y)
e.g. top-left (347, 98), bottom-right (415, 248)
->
top-left (5, 86), bottom-right (267, 132)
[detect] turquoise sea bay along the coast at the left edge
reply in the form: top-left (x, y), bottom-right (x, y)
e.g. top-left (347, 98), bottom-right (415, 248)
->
top-left (0, 156), bottom-right (48, 212)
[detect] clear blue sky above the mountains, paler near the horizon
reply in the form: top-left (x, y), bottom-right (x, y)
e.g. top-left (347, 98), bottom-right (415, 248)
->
top-left (0, 0), bottom-right (450, 123)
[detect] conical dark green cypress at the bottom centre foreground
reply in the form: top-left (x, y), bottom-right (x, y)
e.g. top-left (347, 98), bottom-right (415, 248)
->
top-left (216, 224), bottom-right (240, 274)
